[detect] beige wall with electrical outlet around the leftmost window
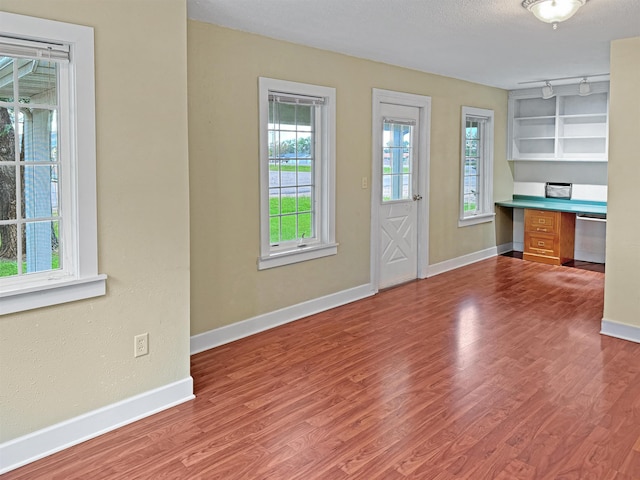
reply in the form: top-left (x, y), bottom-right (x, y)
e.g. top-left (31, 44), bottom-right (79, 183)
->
top-left (0, 0), bottom-right (189, 442)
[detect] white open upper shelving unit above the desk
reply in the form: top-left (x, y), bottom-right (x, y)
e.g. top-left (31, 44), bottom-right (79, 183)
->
top-left (508, 82), bottom-right (609, 162)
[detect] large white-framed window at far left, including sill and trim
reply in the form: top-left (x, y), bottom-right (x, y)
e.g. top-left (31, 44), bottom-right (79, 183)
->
top-left (0, 12), bottom-right (106, 314)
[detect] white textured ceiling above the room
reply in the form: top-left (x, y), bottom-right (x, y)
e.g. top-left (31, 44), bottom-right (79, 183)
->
top-left (188, 0), bottom-right (640, 89)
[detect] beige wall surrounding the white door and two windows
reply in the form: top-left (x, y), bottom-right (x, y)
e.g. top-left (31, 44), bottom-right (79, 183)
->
top-left (188, 21), bottom-right (513, 335)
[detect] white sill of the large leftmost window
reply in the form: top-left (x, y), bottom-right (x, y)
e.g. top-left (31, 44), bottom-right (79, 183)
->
top-left (0, 274), bottom-right (107, 315)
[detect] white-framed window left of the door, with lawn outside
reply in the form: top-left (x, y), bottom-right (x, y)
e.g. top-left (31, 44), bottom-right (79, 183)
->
top-left (258, 78), bottom-right (337, 270)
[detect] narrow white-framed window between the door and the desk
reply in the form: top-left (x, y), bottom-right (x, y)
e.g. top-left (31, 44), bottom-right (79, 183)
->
top-left (458, 107), bottom-right (495, 227)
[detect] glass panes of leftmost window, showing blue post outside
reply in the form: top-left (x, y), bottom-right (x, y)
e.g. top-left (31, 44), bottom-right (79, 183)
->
top-left (0, 55), bottom-right (64, 279)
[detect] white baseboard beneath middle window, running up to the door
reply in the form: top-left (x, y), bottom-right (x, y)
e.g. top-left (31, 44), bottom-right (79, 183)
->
top-left (191, 284), bottom-right (376, 355)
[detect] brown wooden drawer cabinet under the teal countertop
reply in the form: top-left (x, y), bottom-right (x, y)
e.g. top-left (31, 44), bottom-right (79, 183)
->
top-left (523, 208), bottom-right (576, 265)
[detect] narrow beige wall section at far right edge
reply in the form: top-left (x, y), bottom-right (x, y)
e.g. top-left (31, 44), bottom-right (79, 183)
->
top-left (604, 37), bottom-right (640, 327)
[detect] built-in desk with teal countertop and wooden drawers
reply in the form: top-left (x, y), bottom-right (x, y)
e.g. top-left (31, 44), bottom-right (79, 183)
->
top-left (496, 195), bottom-right (607, 265)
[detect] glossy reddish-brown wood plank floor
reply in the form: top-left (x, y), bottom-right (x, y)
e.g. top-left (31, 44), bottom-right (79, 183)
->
top-left (2, 257), bottom-right (640, 480)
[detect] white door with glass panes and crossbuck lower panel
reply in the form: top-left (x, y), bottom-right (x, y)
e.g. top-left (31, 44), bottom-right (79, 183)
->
top-left (377, 103), bottom-right (423, 288)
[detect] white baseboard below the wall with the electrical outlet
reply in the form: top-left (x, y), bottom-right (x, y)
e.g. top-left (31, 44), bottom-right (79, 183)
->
top-left (0, 377), bottom-right (195, 475)
